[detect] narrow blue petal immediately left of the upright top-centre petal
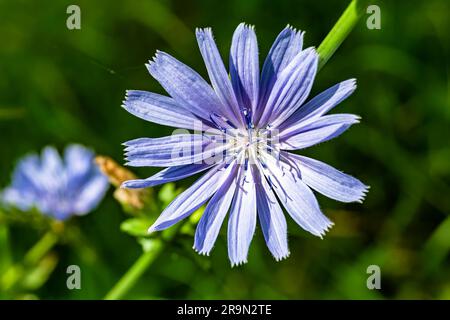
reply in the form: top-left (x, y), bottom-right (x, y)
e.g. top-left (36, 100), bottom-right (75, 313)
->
top-left (196, 28), bottom-right (243, 125)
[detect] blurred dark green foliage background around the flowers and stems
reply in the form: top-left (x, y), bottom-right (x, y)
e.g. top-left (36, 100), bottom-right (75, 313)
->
top-left (0, 0), bottom-right (450, 299)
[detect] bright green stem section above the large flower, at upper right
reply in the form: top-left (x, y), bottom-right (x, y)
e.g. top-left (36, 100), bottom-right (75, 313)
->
top-left (317, 0), bottom-right (365, 70)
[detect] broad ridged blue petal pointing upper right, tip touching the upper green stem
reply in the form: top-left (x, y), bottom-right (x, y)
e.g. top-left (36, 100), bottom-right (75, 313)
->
top-left (258, 48), bottom-right (318, 127)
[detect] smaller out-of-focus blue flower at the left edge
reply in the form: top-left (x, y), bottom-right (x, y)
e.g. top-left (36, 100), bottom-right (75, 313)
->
top-left (0, 144), bottom-right (108, 220)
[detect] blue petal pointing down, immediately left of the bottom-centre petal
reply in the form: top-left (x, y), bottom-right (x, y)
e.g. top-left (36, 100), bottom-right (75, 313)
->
top-left (194, 166), bottom-right (237, 255)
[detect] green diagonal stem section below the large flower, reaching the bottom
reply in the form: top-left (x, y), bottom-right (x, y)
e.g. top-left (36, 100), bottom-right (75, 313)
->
top-left (104, 239), bottom-right (164, 300)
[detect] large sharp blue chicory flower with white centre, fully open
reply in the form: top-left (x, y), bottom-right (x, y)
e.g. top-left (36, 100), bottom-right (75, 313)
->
top-left (123, 24), bottom-right (368, 265)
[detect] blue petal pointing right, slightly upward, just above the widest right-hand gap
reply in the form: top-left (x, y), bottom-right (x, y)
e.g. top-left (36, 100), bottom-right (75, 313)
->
top-left (280, 114), bottom-right (359, 150)
